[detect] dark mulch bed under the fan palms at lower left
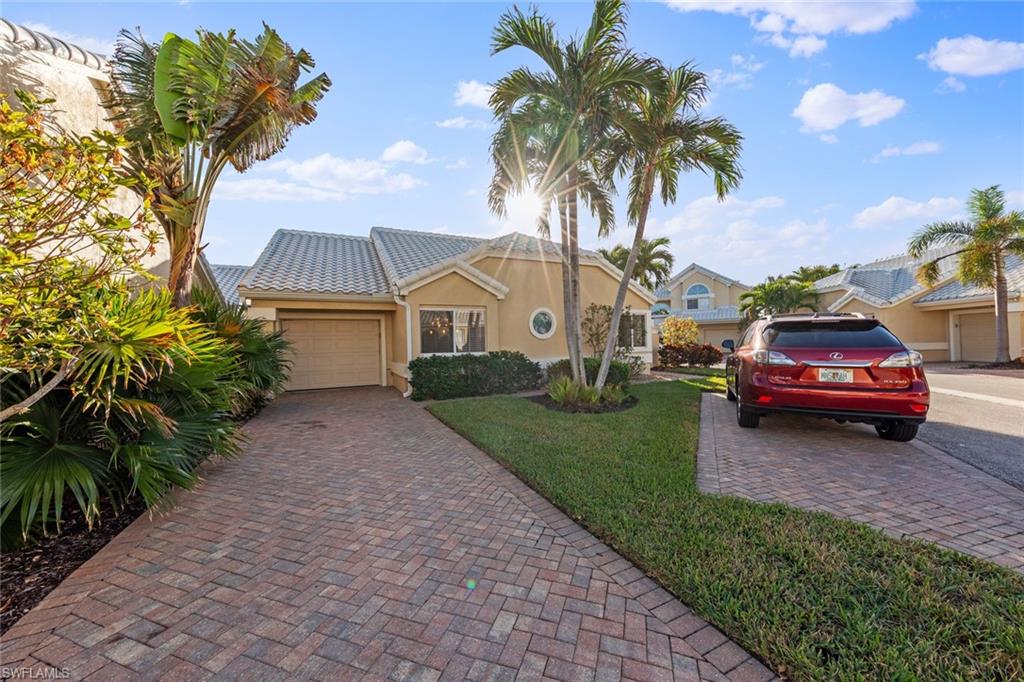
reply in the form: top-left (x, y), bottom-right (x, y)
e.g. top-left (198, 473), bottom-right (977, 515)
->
top-left (0, 495), bottom-right (145, 634)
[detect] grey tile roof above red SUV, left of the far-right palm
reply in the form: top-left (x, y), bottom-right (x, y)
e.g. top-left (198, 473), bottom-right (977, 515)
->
top-left (814, 242), bottom-right (956, 305)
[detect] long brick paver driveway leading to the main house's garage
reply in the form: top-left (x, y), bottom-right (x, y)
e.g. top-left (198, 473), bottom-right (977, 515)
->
top-left (2, 389), bottom-right (771, 681)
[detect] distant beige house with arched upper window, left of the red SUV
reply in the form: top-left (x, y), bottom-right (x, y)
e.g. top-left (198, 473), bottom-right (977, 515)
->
top-left (654, 263), bottom-right (751, 346)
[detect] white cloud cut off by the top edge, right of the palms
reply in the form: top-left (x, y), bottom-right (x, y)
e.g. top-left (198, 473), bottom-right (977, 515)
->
top-left (668, 0), bottom-right (916, 57)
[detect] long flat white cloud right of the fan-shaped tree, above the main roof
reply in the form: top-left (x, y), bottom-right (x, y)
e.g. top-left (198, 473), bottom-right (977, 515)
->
top-left (215, 154), bottom-right (425, 202)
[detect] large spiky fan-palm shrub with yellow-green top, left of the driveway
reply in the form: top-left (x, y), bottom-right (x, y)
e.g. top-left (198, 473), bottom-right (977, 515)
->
top-left (0, 290), bottom-right (241, 541)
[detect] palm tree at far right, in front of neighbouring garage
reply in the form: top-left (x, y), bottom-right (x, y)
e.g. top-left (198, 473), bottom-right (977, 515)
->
top-left (907, 184), bottom-right (1024, 363)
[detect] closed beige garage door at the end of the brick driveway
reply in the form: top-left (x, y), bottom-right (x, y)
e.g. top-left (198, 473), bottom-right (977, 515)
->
top-left (284, 319), bottom-right (381, 391)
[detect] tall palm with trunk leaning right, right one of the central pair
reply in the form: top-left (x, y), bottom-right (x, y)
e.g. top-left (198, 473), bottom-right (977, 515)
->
top-left (595, 63), bottom-right (742, 389)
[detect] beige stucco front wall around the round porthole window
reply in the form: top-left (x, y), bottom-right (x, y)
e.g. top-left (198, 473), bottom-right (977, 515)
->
top-left (473, 256), bottom-right (650, 361)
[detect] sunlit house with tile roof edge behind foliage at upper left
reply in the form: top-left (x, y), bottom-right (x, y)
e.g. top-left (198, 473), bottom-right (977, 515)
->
top-left (0, 18), bottom-right (222, 296)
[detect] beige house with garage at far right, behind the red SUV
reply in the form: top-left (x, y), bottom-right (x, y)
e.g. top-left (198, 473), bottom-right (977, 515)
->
top-left (814, 247), bottom-right (1024, 363)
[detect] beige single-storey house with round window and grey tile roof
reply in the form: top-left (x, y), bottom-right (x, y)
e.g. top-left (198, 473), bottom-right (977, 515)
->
top-left (238, 227), bottom-right (654, 390)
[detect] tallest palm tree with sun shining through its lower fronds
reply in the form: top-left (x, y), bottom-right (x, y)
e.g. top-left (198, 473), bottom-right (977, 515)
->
top-left (489, 0), bottom-right (657, 383)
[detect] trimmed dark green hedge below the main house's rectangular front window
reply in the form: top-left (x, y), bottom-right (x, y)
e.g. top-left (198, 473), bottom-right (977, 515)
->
top-left (409, 350), bottom-right (544, 400)
